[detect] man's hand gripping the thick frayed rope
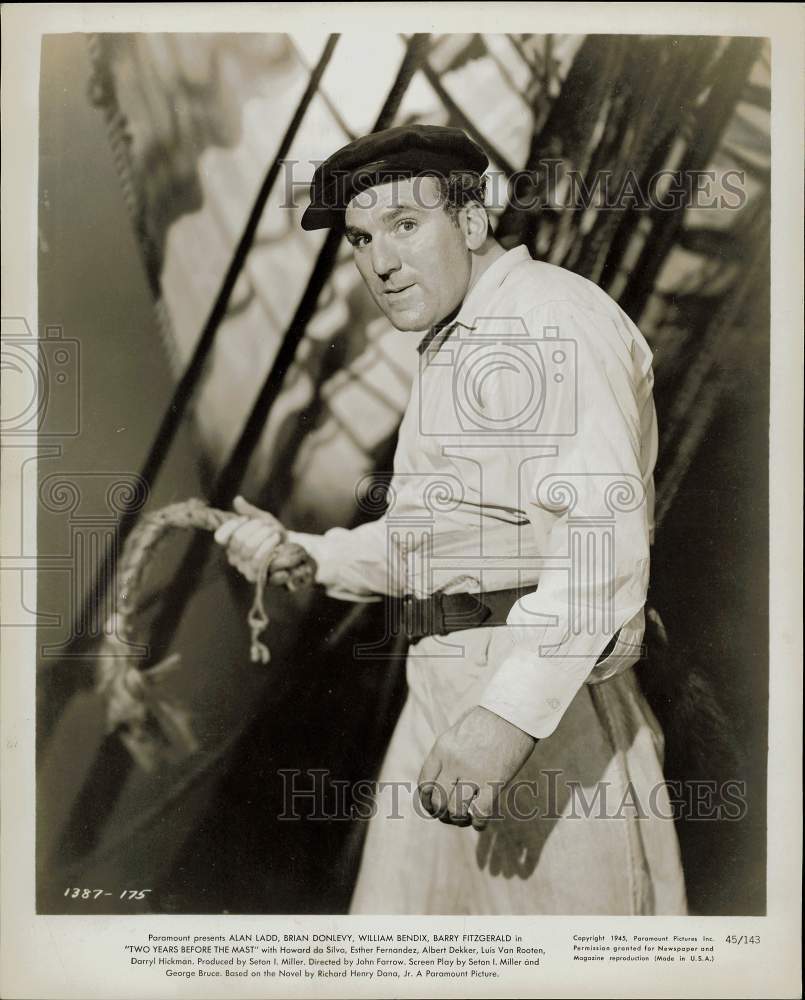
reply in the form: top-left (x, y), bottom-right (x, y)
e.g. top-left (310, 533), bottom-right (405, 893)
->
top-left (215, 497), bottom-right (316, 590)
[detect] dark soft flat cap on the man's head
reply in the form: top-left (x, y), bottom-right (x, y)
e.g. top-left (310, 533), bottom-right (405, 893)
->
top-left (302, 125), bottom-right (489, 230)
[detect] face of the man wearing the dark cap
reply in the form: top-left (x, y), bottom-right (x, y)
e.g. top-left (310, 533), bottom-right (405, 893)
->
top-left (345, 177), bottom-right (471, 330)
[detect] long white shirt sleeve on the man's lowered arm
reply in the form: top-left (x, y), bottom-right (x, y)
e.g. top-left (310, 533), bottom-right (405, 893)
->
top-left (479, 302), bottom-right (656, 738)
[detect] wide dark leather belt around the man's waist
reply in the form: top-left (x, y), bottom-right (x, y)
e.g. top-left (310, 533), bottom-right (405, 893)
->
top-left (394, 585), bottom-right (620, 663)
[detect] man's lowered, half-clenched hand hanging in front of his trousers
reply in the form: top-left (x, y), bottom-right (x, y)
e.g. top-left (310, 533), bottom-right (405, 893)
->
top-left (419, 705), bottom-right (537, 830)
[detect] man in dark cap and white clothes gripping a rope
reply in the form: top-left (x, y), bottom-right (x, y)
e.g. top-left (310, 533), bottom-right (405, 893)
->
top-left (216, 125), bottom-right (685, 914)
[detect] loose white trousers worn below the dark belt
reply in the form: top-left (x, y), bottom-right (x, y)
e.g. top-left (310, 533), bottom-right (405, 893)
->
top-left (350, 628), bottom-right (686, 915)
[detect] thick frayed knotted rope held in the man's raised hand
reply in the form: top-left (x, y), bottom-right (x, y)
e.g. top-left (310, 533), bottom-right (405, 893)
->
top-left (96, 499), bottom-right (307, 770)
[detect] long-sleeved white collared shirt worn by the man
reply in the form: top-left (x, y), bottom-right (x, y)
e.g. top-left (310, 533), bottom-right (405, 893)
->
top-left (289, 246), bottom-right (657, 738)
